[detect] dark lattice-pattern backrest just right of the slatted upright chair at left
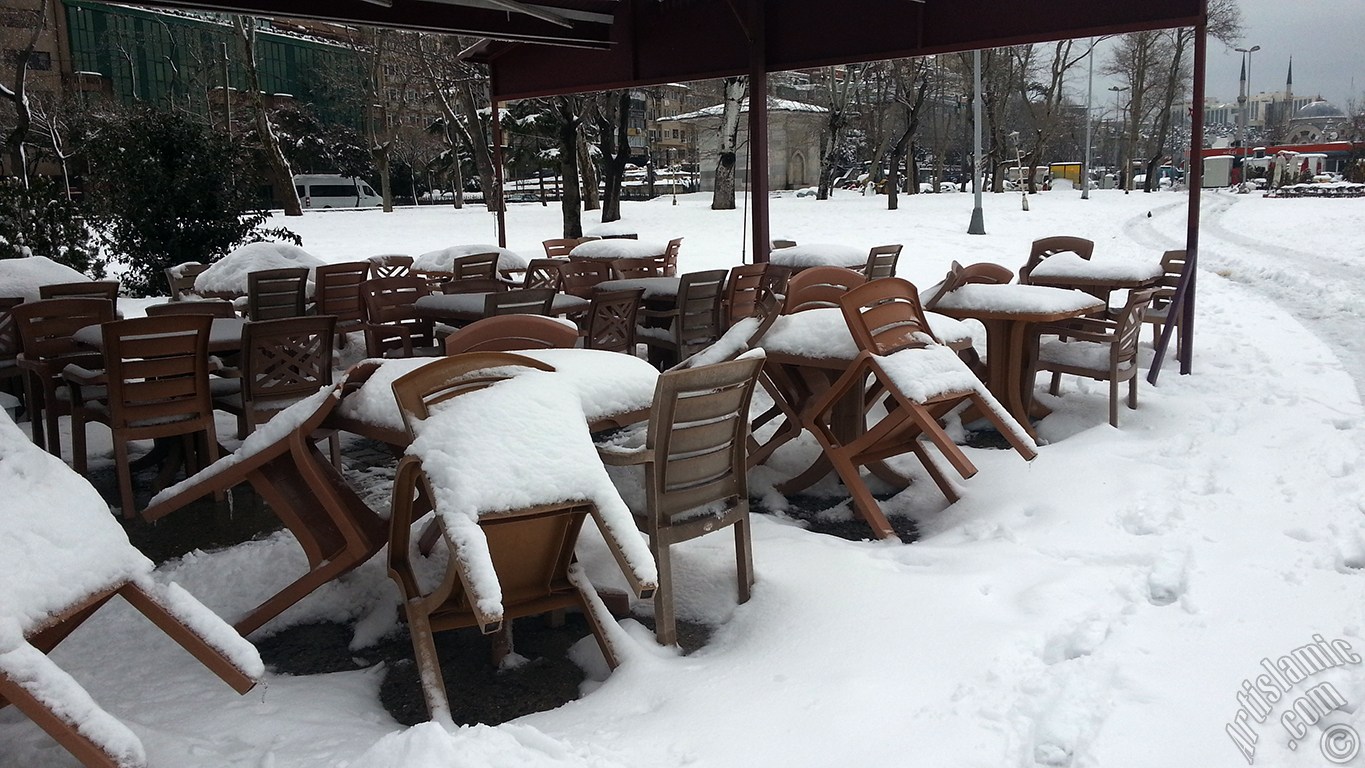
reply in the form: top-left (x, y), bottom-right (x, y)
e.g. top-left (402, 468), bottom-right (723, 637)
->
top-left (242, 315), bottom-right (337, 408)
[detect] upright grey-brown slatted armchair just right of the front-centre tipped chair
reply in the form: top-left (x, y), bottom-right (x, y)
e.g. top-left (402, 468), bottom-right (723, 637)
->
top-left (599, 357), bottom-right (763, 645)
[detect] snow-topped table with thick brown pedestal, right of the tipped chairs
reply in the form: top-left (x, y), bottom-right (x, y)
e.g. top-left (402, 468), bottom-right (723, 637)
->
top-left (934, 283), bottom-right (1104, 439)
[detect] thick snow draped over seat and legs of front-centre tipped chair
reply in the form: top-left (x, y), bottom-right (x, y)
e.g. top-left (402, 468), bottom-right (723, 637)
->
top-left (408, 373), bottom-right (658, 624)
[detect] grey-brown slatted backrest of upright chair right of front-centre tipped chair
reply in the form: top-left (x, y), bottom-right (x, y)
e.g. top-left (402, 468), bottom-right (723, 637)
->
top-left (644, 357), bottom-right (763, 527)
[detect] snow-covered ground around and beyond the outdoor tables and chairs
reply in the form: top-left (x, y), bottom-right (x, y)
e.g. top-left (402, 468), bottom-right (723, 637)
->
top-left (0, 191), bottom-right (1365, 768)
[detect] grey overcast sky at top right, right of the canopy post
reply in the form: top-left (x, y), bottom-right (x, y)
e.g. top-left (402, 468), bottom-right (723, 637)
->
top-left (1205, 0), bottom-right (1365, 109)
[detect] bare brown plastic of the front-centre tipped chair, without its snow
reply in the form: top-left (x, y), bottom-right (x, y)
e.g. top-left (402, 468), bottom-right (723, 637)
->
top-left (389, 352), bottom-right (655, 722)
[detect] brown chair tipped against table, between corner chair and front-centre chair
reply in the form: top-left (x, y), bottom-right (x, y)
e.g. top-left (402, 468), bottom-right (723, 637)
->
top-left (142, 368), bottom-right (387, 634)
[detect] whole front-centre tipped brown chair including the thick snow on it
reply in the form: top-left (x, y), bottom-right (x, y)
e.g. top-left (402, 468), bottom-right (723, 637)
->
top-left (389, 352), bottom-right (657, 724)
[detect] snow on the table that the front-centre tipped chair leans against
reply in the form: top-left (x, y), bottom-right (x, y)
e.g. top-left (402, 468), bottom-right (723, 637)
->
top-left (337, 349), bottom-right (659, 431)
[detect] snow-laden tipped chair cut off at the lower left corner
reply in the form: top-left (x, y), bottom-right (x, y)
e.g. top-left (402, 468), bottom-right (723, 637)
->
top-left (0, 416), bottom-right (265, 768)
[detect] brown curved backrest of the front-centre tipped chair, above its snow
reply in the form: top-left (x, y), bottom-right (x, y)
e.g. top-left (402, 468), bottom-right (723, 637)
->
top-left (393, 352), bottom-right (554, 438)
